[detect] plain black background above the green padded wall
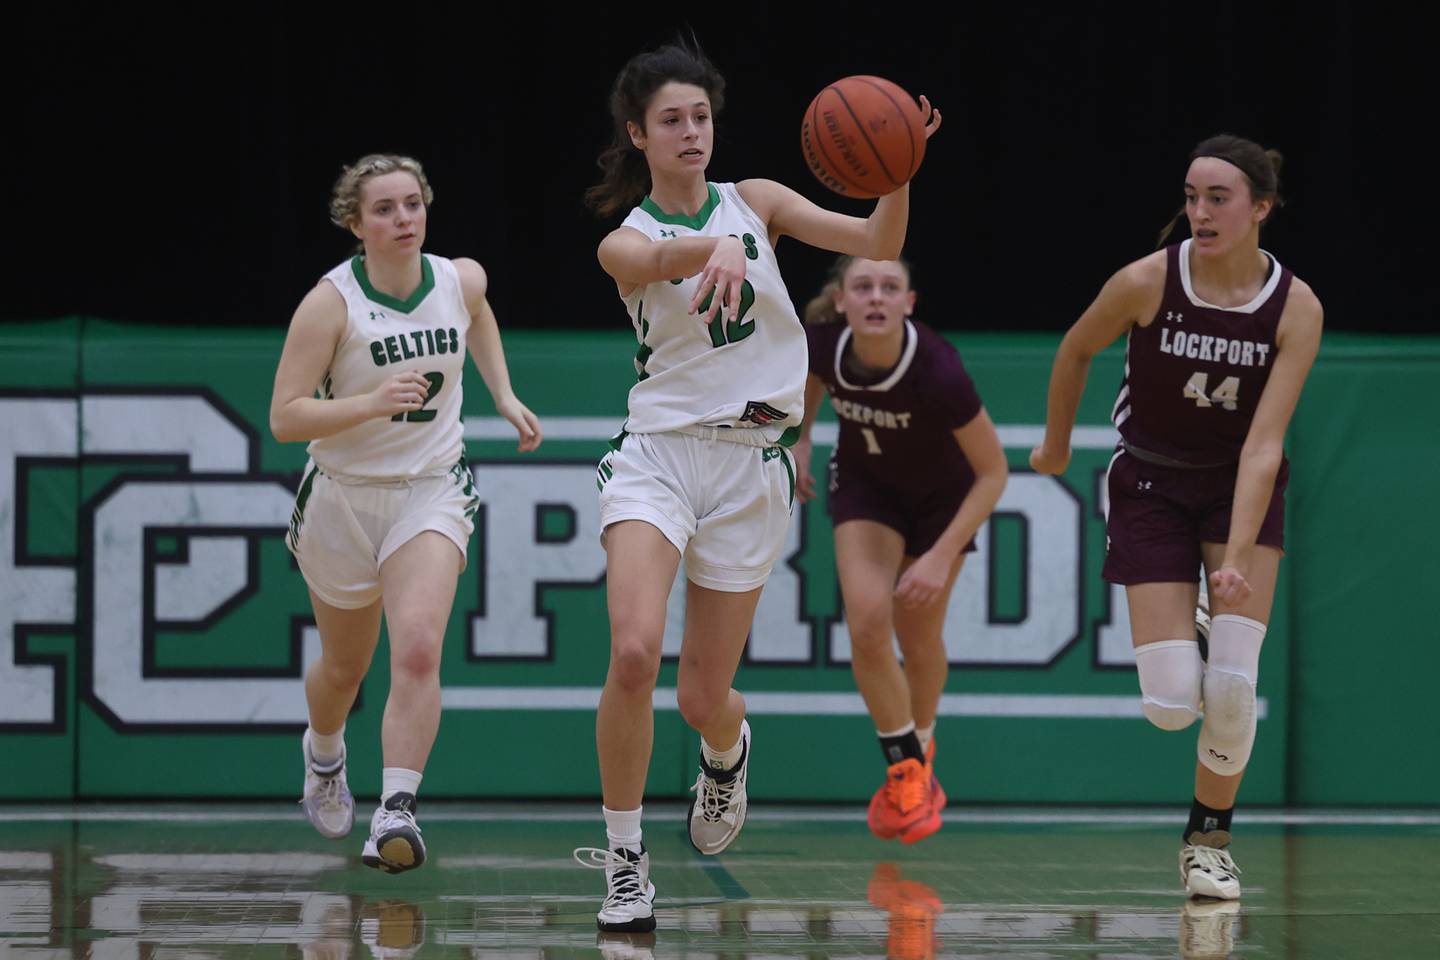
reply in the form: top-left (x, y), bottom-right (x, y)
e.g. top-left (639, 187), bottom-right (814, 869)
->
top-left (8, 3), bottom-right (1437, 332)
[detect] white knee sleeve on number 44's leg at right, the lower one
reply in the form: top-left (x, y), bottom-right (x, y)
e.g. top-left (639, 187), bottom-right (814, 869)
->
top-left (1195, 613), bottom-right (1266, 777)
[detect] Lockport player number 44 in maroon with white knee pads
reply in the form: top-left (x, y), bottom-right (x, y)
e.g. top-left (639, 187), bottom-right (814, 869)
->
top-left (1030, 135), bottom-right (1322, 900)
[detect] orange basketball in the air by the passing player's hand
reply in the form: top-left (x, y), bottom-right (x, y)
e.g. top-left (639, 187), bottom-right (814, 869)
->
top-left (801, 76), bottom-right (924, 199)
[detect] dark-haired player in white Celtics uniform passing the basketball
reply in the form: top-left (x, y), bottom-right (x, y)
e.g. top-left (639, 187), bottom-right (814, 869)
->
top-left (576, 45), bottom-right (940, 933)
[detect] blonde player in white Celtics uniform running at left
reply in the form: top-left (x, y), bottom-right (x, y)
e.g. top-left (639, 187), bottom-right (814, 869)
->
top-left (271, 154), bottom-right (541, 872)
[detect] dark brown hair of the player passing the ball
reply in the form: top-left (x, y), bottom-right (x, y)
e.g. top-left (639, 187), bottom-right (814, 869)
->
top-left (585, 39), bottom-right (724, 216)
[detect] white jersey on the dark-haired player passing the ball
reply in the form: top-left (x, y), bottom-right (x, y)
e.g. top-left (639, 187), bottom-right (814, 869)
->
top-left (622, 183), bottom-right (809, 443)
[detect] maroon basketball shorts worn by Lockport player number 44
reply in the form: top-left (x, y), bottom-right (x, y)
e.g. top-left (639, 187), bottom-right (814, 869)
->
top-left (1102, 453), bottom-right (1290, 586)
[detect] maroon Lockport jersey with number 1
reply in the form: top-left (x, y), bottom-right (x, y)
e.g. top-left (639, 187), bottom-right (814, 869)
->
top-left (805, 320), bottom-right (981, 498)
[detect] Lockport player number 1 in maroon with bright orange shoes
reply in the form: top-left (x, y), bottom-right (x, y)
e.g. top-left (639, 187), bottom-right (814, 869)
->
top-left (795, 256), bottom-right (1009, 843)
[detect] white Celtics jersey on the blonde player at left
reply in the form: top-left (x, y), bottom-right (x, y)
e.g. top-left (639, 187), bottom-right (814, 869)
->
top-left (308, 253), bottom-right (469, 481)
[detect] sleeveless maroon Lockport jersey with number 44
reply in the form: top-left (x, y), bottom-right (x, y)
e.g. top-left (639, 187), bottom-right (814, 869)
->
top-left (1112, 240), bottom-right (1293, 466)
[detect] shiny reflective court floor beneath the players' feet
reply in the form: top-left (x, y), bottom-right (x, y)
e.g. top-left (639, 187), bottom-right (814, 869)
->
top-left (0, 800), bottom-right (1440, 960)
